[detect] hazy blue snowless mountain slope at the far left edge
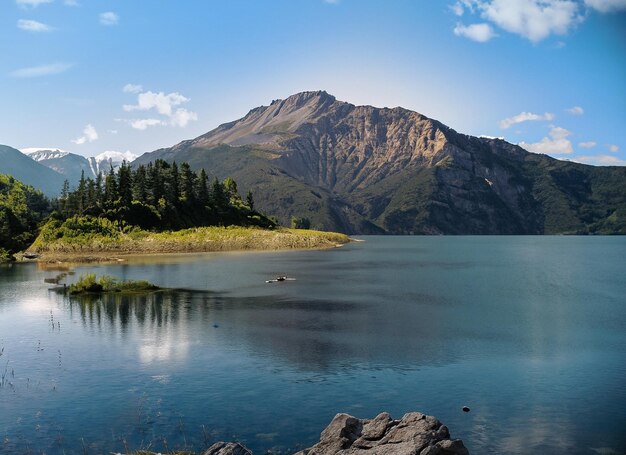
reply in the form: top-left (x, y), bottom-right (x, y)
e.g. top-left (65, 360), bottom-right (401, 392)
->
top-left (0, 145), bottom-right (65, 196)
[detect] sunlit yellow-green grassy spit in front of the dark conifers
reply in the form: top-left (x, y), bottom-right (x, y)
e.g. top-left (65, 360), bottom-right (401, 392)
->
top-left (30, 217), bottom-right (349, 262)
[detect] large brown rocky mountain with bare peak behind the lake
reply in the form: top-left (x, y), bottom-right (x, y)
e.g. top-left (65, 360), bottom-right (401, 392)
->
top-left (134, 91), bottom-right (626, 234)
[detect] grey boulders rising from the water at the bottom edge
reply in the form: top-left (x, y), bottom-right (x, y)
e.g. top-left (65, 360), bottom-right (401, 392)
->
top-left (203, 412), bottom-right (469, 455)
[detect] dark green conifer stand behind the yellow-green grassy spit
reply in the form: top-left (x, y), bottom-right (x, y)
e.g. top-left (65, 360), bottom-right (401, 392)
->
top-left (54, 160), bottom-right (276, 230)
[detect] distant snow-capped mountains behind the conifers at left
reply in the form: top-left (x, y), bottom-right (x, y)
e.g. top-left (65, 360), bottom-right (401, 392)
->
top-left (22, 148), bottom-right (137, 186)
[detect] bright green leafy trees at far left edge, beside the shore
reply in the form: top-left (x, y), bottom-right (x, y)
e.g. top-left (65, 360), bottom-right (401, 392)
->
top-left (0, 174), bottom-right (49, 262)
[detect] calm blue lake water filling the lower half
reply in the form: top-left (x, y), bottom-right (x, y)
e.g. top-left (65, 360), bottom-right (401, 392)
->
top-left (0, 237), bottom-right (626, 454)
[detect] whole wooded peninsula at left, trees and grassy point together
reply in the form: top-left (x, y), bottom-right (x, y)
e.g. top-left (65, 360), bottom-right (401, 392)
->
top-left (0, 160), bottom-right (350, 262)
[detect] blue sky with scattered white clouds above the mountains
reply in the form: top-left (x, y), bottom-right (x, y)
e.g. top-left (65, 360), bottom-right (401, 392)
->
top-left (0, 0), bottom-right (626, 165)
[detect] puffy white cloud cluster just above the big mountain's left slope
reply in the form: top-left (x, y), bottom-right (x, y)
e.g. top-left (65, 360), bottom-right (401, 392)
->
top-left (122, 89), bottom-right (198, 130)
